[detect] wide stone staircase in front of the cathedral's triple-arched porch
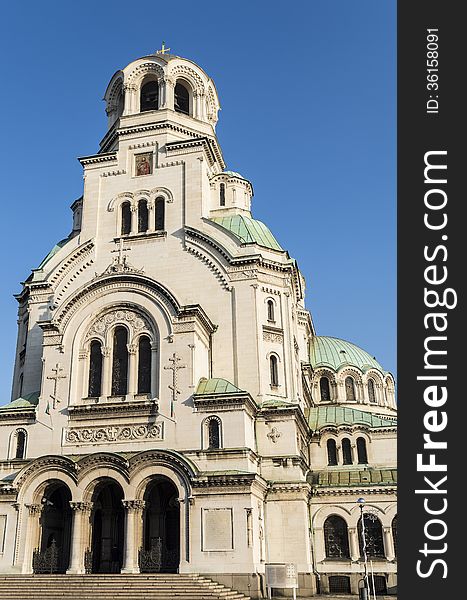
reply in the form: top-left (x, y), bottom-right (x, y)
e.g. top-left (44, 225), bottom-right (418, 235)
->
top-left (0, 574), bottom-right (249, 600)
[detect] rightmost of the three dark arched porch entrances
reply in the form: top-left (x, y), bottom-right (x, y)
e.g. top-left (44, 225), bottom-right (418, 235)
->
top-left (140, 476), bottom-right (180, 573)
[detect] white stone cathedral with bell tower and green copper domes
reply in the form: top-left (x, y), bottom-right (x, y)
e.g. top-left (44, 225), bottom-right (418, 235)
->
top-left (0, 48), bottom-right (397, 598)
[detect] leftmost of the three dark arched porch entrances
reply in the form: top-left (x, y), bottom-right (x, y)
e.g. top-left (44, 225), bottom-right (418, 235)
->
top-left (33, 481), bottom-right (72, 573)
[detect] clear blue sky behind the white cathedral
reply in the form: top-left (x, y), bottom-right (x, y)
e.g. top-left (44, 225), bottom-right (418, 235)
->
top-left (0, 0), bottom-right (396, 404)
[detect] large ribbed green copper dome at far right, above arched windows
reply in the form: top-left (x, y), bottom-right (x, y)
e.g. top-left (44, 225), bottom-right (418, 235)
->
top-left (310, 335), bottom-right (386, 373)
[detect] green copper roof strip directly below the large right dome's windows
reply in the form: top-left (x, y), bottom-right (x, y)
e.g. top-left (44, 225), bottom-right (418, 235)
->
top-left (308, 406), bottom-right (397, 431)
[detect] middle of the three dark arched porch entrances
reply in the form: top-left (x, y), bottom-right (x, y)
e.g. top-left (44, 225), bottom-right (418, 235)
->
top-left (90, 480), bottom-right (125, 573)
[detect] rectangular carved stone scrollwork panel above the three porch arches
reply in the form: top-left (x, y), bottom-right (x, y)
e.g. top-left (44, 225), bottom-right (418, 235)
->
top-left (65, 423), bottom-right (164, 444)
